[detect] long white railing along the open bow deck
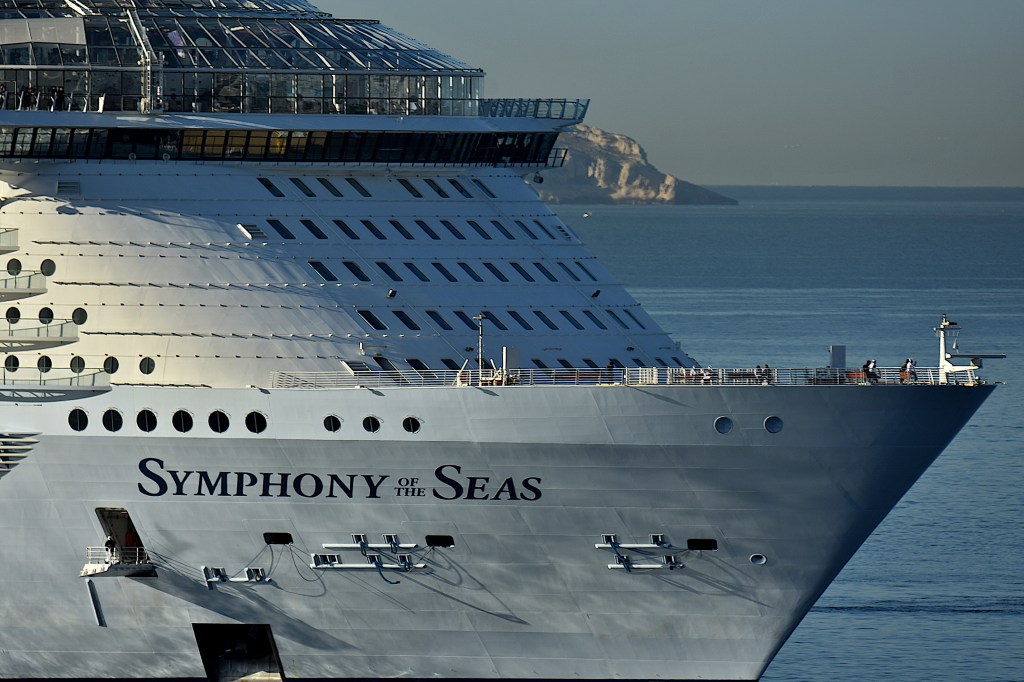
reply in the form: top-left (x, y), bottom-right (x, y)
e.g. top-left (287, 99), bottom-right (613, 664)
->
top-left (271, 367), bottom-right (958, 389)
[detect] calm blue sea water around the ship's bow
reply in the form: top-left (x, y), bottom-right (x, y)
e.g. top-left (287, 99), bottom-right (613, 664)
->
top-left (558, 188), bottom-right (1024, 682)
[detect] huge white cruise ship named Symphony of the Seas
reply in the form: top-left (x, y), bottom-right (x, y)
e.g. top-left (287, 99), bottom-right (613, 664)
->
top-left (0, 0), bottom-right (993, 680)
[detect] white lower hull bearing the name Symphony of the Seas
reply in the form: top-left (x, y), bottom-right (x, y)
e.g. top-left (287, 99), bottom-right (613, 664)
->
top-left (0, 378), bottom-right (989, 680)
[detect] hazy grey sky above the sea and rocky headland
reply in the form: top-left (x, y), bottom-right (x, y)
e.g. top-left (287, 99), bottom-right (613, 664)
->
top-left (323, 0), bottom-right (1024, 186)
